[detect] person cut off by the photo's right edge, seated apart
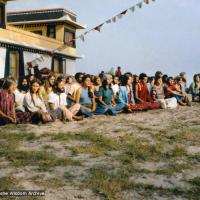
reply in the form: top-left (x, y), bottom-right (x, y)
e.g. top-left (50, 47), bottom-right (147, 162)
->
top-left (189, 74), bottom-right (200, 102)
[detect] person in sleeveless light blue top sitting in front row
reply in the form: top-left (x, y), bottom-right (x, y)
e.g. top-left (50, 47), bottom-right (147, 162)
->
top-left (76, 75), bottom-right (96, 117)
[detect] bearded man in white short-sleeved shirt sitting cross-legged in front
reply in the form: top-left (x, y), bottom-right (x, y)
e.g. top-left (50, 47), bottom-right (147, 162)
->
top-left (48, 79), bottom-right (83, 122)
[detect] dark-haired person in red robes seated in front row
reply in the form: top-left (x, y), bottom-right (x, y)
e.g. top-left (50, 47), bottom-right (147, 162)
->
top-left (135, 73), bottom-right (160, 110)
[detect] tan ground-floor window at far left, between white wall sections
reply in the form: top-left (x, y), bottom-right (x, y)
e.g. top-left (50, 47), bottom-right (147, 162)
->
top-left (9, 51), bottom-right (19, 80)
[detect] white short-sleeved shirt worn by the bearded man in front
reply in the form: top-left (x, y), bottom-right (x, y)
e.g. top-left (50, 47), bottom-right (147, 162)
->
top-left (48, 92), bottom-right (67, 109)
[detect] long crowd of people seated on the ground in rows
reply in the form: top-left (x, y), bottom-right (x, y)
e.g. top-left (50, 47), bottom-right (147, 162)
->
top-left (0, 67), bottom-right (200, 125)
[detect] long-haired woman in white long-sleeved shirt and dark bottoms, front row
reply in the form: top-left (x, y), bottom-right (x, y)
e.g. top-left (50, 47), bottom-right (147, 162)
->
top-left (24, 79), bottom-right (52, 124)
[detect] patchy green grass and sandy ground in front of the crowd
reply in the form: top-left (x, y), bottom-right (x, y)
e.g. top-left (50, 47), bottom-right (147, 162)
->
top-left (0, 104), bottom-right (200, 200)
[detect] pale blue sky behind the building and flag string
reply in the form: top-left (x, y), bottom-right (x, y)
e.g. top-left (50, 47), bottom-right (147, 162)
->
top-left (8, 0), bottom-right (200, 83)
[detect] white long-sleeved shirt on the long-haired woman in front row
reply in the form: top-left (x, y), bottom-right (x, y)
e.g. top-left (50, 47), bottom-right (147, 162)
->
top-left (23, 92), bottom-right (47, 112)
